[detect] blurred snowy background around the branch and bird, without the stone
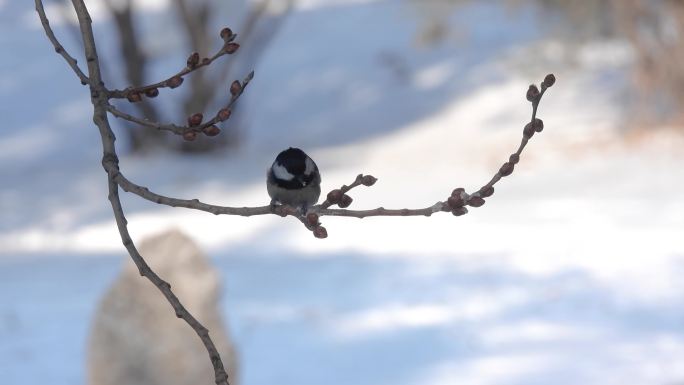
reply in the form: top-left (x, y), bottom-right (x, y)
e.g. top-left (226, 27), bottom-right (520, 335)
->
top-left (0, 0), bottom-right (684, 385)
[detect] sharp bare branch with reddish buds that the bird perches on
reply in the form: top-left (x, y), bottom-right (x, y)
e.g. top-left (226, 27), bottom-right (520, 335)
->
top-left (35, 0), bottom-right (555, 385)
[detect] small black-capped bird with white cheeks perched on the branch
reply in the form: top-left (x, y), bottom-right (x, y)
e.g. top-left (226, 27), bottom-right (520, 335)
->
top-left (266, 147), bottom-right (321, 213)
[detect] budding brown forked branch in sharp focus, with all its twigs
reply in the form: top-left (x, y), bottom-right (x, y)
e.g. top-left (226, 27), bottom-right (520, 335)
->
top-left (35, 0), bottom-right (555, 385)
